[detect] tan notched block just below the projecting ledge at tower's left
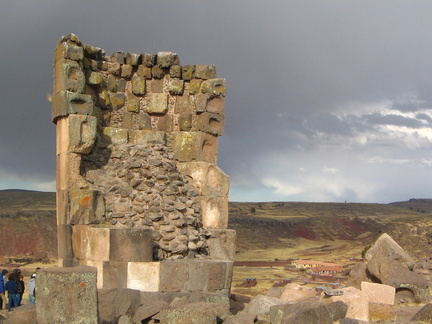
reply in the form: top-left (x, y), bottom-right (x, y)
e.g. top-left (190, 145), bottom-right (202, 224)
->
top-left (68, 115), bottom-right (97, 154)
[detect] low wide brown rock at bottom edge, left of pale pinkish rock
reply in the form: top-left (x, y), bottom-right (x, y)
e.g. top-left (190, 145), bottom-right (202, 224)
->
top-left (269, 301), bottom-right (333, 324)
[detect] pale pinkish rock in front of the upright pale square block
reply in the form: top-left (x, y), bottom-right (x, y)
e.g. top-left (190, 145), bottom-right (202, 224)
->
top-left (320, 287), bottom-right (369, 322)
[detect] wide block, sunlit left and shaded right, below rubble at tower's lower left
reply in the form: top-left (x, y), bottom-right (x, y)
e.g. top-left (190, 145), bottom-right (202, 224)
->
top-left (72, 225), bottom-right (153, 262)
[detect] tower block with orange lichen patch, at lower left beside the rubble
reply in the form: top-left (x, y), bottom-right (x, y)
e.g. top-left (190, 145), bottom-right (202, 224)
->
top-left (69, 189), bottom-right (105, 225)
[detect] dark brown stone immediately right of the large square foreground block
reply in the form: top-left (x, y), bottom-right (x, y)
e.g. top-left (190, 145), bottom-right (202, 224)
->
top-left (97, 289), bottom-right (141, 323)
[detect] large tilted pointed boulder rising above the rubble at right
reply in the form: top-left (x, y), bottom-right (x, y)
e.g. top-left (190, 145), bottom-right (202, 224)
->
top-left (366, 233), bottom-right (415, 284)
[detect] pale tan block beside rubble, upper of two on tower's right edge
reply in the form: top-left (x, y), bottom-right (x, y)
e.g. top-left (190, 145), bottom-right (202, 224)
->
top-left (178, 162), bottom-right (230, 197)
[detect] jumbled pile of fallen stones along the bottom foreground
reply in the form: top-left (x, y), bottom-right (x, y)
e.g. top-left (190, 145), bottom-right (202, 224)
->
top-left (4, 234), bottom-right (432, 324)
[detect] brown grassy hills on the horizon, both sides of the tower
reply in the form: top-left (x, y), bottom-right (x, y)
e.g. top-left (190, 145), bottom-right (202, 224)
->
top-left (0, 190), bottom-right (432, 257)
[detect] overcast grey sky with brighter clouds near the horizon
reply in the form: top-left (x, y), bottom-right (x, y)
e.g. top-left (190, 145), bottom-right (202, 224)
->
top-left (0, 0), bottom-right (432, 203)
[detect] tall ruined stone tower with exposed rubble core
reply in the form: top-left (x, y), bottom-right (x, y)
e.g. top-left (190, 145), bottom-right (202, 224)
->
top-left (52, 34), bottom-right (235, 293)
